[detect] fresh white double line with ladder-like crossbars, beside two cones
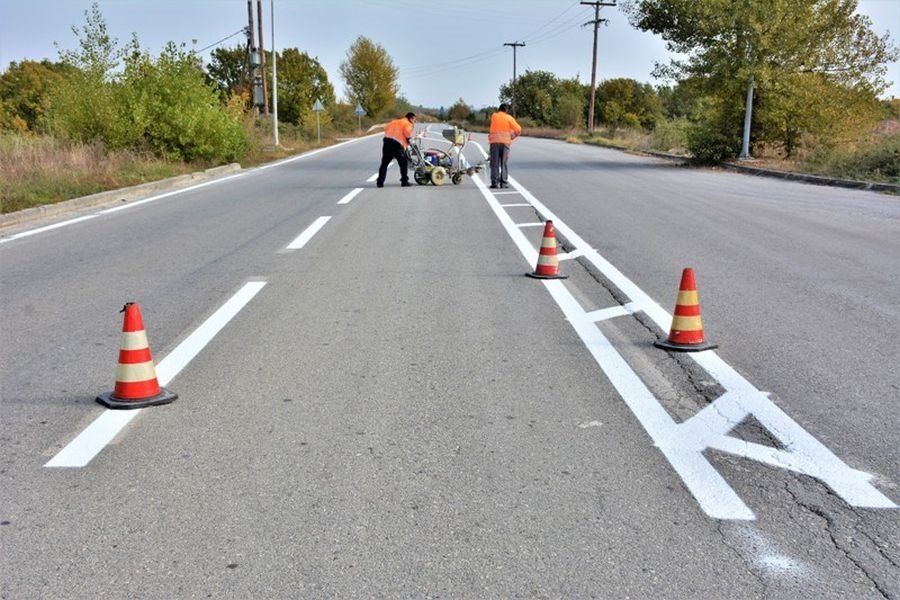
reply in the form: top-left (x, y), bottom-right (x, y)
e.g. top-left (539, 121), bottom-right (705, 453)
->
top-left (476, 171), bottom-right (896, 520)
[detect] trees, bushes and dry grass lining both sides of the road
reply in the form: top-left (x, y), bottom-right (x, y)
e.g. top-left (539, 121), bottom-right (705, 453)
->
top-left (0, 0), bottom-right (900, 212)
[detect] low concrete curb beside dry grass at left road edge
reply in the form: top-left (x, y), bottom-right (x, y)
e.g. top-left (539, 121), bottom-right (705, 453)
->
top-left (0, 163), bottom-right (241, 229)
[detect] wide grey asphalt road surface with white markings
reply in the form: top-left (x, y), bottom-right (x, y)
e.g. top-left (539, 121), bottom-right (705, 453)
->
top-left (0, 129), bottom-right (900, 598)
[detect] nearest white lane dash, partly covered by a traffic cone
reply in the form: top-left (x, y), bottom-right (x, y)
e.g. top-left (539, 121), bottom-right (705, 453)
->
top-left (44, 281), bottom-right (266, 467)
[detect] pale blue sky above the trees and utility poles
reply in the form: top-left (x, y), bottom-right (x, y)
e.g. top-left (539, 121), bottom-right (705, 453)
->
top-left (0, 0), bottom-right (900, 109)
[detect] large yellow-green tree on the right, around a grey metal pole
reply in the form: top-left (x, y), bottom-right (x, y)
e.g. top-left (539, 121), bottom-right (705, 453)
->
top-left (626, 0), bottom-right (898, 158)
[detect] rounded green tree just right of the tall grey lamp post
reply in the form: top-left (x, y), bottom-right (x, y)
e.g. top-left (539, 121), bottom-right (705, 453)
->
top-left (269, 48), bottom-right (335, 128)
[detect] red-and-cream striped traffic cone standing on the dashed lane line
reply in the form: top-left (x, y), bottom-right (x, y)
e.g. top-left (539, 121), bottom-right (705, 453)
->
top-left (97, 302), bottom-right (178, 408)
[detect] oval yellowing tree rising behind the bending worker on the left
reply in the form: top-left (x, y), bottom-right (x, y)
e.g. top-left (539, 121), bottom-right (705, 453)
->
top-left (340, 36), bottom-right (400, 117)
